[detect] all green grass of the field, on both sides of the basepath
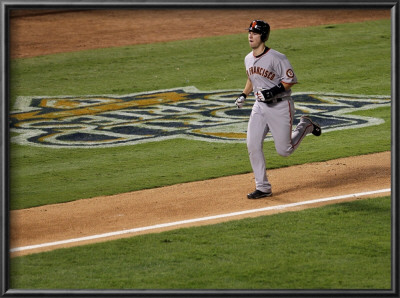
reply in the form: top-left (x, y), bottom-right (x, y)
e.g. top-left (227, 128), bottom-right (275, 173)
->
top-left (10, 20), bottom-right (391, 289)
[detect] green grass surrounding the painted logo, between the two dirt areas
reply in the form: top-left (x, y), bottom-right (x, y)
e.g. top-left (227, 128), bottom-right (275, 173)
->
top-left (10, 21), bottom-right (390, 209)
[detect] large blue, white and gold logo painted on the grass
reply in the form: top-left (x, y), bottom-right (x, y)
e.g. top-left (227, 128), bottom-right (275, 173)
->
top-left (10, 87), bottom-right (390, 148)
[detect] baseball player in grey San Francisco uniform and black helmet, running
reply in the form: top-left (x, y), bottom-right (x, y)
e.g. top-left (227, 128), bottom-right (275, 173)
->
top-left (235, 20), bottom-right (321, 199)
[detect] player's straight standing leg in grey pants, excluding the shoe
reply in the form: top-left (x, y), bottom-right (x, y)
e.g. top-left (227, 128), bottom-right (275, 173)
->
top-left (247, 102), bottom-right (271, 192)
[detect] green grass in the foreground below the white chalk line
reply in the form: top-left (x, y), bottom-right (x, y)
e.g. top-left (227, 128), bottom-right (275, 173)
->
top-left (11, 197), bottom-right (391, 290)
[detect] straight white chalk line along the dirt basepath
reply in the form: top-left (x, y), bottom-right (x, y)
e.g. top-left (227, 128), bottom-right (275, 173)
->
top-left (10, 188), bottom-right (390, 252)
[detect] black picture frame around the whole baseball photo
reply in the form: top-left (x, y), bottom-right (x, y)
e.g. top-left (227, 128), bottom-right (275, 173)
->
top-left (0, 0), bottom-right (400, 297)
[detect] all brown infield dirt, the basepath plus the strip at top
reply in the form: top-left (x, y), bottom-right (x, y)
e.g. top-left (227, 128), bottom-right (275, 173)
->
top-left (10, 9), bottom-right (391, 256)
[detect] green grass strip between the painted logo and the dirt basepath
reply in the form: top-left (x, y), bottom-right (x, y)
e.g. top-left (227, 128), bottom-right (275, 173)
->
top-left (11, 108), bottom-right (391, 209)
